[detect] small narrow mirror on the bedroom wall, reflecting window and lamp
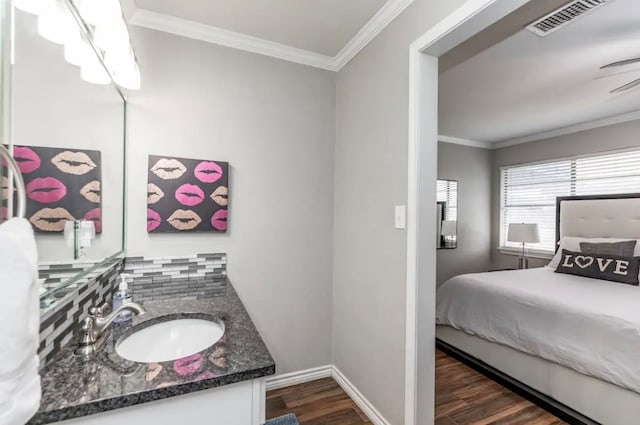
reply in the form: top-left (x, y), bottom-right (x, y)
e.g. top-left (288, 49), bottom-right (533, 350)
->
top-left (436, 180), bottom-right (458, 249)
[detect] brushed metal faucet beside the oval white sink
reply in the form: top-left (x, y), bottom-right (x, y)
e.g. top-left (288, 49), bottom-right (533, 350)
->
top-left (74, 303), bottom-right (145, 355)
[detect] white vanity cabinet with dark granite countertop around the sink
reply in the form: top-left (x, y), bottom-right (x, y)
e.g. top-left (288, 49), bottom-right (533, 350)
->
top-left (29, 281), bottom-right (275, 425)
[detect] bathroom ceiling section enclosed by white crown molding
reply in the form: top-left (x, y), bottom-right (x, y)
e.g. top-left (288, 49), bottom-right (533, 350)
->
top-left (136, 0), bottom-right (388, 57)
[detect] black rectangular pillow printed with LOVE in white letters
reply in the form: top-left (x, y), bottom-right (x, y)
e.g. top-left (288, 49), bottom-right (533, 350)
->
top-left (556, 249), bottom-right (640, 285)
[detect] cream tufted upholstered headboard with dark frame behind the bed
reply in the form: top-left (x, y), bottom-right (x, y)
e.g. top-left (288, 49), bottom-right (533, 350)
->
top-left (556, 193), bottom-right (640, 246)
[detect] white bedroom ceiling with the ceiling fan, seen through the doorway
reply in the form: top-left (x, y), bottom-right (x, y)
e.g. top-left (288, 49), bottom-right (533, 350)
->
top-left (439, 0), bottom-right (640, 142)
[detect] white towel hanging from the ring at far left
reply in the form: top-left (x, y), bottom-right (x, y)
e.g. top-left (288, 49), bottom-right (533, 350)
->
top-left (0, 218), bottom-right (41, 425)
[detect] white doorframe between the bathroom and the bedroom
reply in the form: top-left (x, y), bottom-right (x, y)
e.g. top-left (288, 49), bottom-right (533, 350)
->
top-left (404, 0), bottom-right (533, 425)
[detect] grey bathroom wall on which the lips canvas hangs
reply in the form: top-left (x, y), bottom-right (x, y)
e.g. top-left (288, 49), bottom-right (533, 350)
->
top-left (127, 27), bottom-right (335, 373)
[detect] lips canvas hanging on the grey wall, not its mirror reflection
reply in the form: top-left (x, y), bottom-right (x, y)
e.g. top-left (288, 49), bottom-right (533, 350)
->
top-left (147, 155), bottom-right (229, 233)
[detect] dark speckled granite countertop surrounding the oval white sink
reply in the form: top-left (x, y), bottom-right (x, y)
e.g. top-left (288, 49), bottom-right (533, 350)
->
top-left (28, 283), bottom-right (275, 425)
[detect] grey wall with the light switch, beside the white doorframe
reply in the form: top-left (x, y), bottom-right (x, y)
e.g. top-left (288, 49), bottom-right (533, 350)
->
top-left (333, 0), bottom-right (463, 425)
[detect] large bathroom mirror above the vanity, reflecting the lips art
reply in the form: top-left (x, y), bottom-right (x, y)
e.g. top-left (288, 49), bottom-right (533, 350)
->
top-left (2, 0), bottom-right (125, 306)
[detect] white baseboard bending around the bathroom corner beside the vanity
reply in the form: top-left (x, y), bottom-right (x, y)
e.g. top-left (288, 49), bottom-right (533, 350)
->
top-left (267, 365), bottom-right (390, 425)
